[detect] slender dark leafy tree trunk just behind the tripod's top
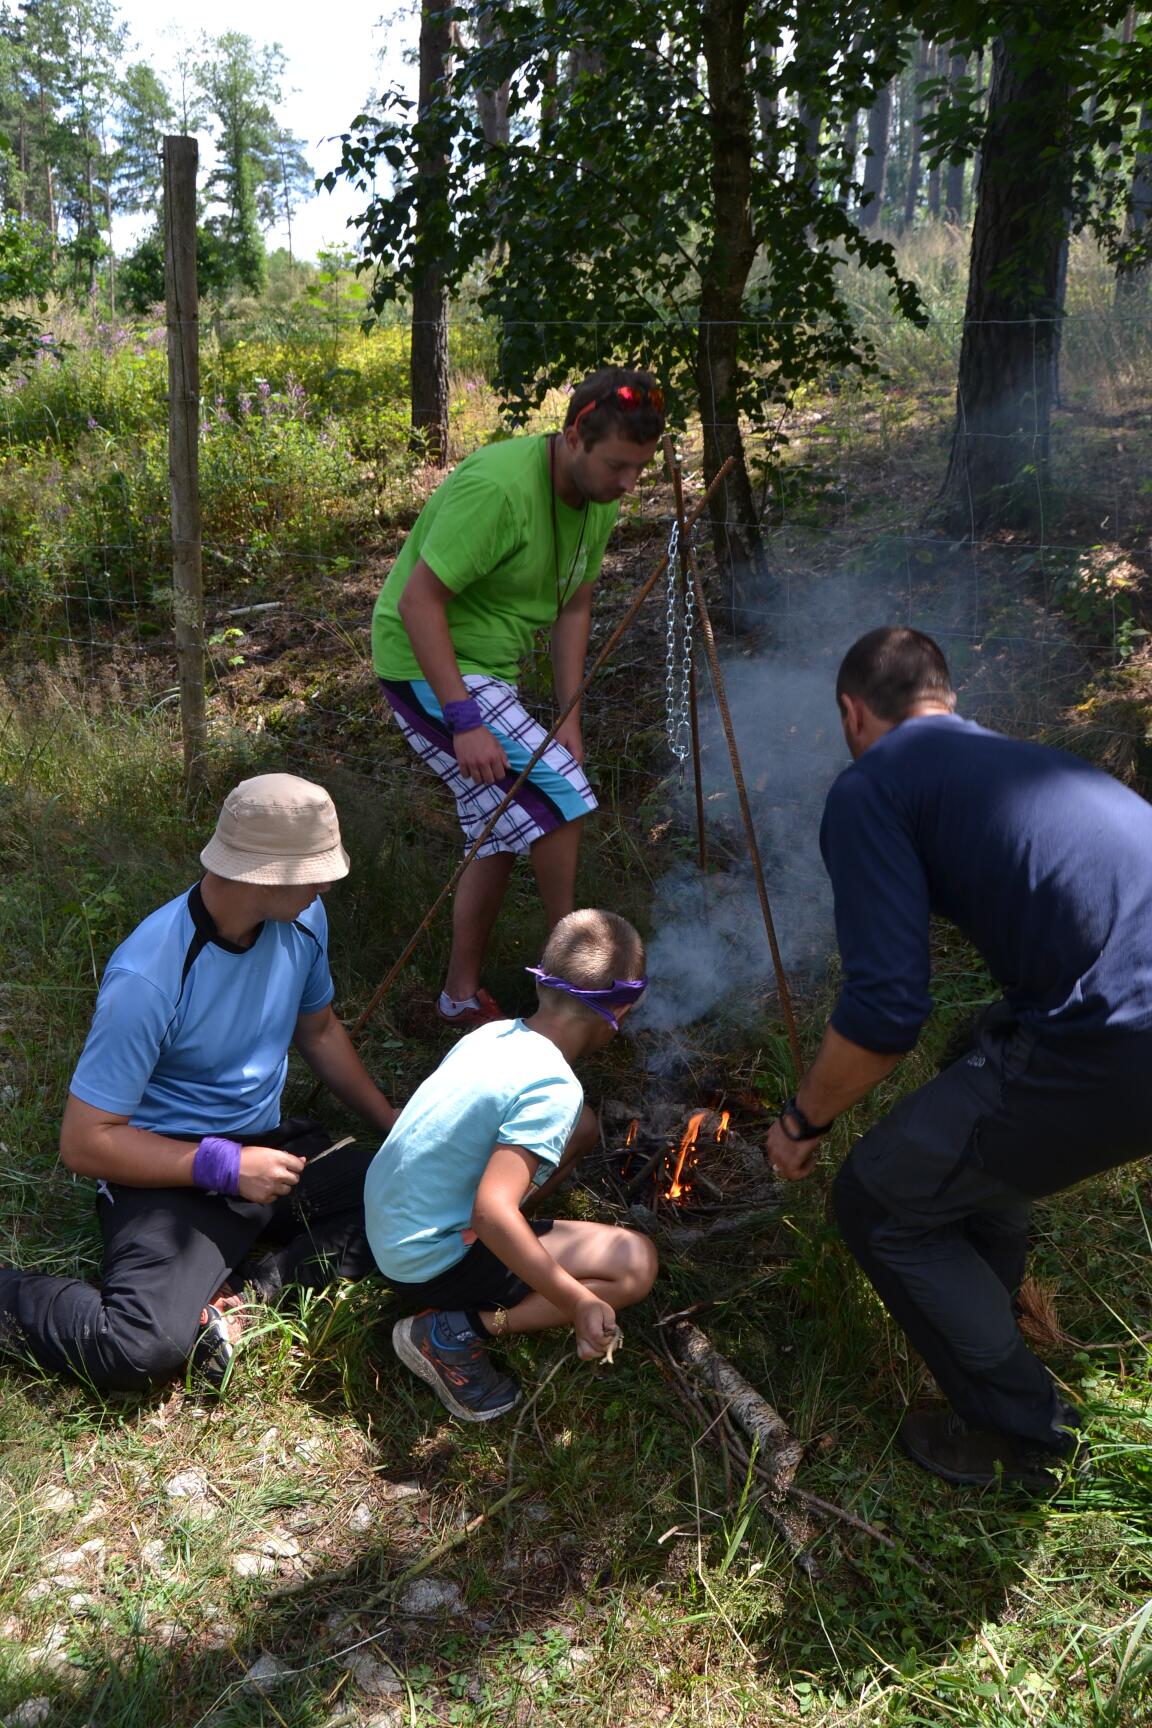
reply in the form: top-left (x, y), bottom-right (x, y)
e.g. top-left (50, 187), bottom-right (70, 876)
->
top-left (696, 0), bottom-right (767, 622)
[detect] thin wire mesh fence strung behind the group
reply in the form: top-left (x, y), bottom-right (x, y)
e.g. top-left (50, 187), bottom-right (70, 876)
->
top-left (0, 294), bottom-right (1152, 781)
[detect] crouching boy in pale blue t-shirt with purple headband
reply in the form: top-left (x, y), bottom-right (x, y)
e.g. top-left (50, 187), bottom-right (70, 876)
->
top-left (364, 911), bottom-right (656, 1422)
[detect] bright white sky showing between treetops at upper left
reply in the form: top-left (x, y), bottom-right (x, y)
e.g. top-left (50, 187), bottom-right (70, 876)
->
top-left (116, 0), bottom-right (418, 257)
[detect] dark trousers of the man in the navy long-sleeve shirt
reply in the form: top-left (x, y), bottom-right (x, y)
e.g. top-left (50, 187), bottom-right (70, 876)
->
top-left (832, 1007), bottom-right (1152, 1450)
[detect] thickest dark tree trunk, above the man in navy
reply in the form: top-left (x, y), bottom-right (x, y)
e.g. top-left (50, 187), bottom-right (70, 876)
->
top-left (936, 36), bottom-right (1073, 534)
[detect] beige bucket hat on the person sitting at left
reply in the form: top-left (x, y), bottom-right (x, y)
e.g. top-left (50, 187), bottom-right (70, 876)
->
top-left (200, 774), bottom-right (349, 888)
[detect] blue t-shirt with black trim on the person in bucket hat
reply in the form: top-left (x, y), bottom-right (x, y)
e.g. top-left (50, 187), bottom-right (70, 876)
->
top-left (71, 886), bottom-right (333, 1135)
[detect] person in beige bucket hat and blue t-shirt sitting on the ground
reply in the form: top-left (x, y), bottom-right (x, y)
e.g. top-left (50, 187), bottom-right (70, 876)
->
top-left (0, 774), bottom-right (396, 1389)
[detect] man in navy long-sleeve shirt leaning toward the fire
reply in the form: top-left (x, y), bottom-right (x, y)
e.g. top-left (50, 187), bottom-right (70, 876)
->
top-left (769, 629), bottom-right (1152, 1484)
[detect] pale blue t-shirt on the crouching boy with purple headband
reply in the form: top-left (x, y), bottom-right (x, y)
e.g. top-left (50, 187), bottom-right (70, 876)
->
top-left (364, 1020), bottom-right (584, 1284)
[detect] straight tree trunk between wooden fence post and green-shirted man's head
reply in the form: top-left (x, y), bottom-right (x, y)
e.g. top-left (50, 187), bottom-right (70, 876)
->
top-left (411, 0), bottom-right (453, 468)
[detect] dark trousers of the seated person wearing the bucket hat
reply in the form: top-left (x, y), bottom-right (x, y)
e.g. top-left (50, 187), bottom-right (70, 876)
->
top-left (0, 1120), bottom-right (373, 1389)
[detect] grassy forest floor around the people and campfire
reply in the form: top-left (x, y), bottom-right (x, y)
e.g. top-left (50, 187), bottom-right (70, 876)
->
top-left (0, 269), bottom-right (1152, 1728)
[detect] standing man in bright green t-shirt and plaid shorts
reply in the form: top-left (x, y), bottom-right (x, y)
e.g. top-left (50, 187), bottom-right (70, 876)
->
top-left (371, 366), bottom-right (663, 1028)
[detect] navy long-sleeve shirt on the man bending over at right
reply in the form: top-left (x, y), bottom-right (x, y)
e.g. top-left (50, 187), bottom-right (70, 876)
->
top-left (820, 714), bottom-right (1152, 1052)
